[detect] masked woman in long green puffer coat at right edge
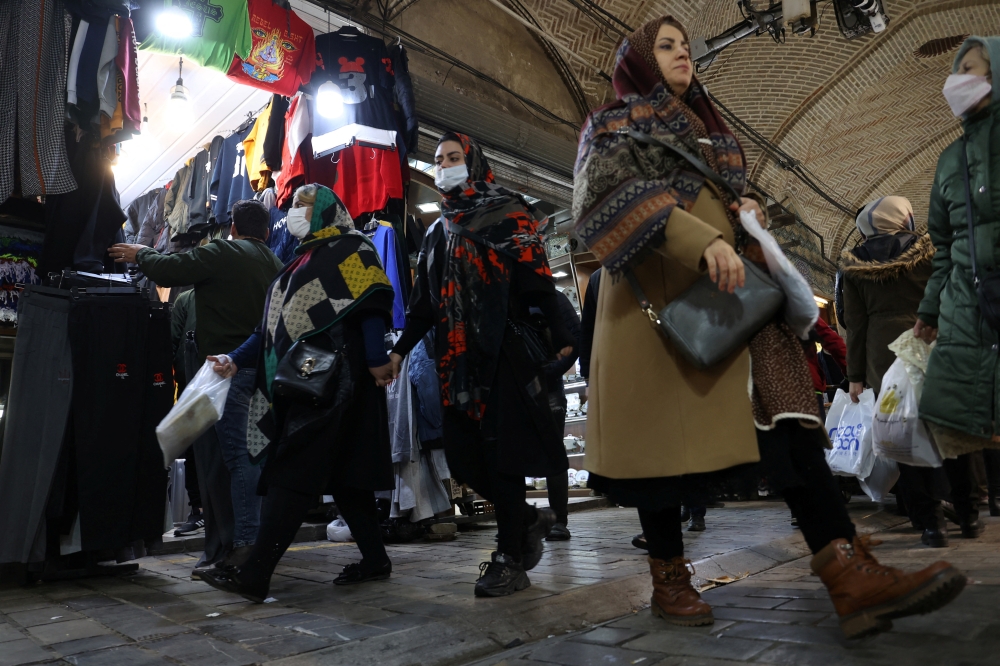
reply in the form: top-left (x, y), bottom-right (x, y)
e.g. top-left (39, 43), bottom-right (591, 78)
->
top-left (913, 37), bottom-right (1000, 535)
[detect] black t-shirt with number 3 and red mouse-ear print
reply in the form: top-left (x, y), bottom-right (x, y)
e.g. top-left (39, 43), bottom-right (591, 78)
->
top-left (309, 28), bottom-right (398, 136)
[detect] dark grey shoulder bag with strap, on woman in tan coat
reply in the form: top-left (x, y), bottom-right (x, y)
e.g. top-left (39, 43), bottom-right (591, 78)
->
top-left (621, 128), bottom-right (785, 370)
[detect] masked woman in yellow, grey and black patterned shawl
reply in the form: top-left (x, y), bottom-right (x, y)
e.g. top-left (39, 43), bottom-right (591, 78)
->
top-left (195, 184), bottom-right (394, 603)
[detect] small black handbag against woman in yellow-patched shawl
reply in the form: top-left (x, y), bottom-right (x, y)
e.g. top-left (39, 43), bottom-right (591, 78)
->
top-left (271, 338), bottom-right (348, 407)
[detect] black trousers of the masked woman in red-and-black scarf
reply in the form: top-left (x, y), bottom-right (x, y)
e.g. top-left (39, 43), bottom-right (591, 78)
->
top-left (444, 409), bottom-right (536, 561)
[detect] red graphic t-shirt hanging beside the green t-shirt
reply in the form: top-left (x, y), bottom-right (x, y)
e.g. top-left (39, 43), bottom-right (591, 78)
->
top-left (228, 0), bottom-right (316, 96)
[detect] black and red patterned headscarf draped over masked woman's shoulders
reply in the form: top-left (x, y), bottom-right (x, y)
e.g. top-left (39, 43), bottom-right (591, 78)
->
top-left (437, 134), bottom-right (552, 420)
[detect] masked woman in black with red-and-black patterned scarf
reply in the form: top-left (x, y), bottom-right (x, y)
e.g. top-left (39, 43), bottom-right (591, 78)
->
top-left (390, 133), bottom-right (574, 597)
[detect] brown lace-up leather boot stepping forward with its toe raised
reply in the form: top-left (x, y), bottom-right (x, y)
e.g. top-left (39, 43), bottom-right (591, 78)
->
top-left (811, 537), bottom-right (965, 638)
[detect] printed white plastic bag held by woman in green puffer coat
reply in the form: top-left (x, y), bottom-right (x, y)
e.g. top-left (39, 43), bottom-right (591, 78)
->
top-left (872, 356), bottom-right (941, 467)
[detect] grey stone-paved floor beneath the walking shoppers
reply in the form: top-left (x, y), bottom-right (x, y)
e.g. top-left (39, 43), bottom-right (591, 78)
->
top-left (0, 502), bottom-right (968, 666)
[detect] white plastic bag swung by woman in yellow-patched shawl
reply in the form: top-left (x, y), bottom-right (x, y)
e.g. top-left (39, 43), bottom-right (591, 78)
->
top-left (156, 361), bottom-right (232, 467)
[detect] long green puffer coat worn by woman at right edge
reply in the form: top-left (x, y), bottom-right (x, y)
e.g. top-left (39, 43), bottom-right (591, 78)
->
top-left (918, 37), bottom-right (1000, 438)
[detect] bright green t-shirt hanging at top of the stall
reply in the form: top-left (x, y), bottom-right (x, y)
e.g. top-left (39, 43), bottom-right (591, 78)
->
top-left (139, 0), bottom-right (253, 72)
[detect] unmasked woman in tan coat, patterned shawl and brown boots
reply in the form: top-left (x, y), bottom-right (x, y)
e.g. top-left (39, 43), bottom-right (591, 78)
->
top-left (573, 17), bottom-right (965, 637)
